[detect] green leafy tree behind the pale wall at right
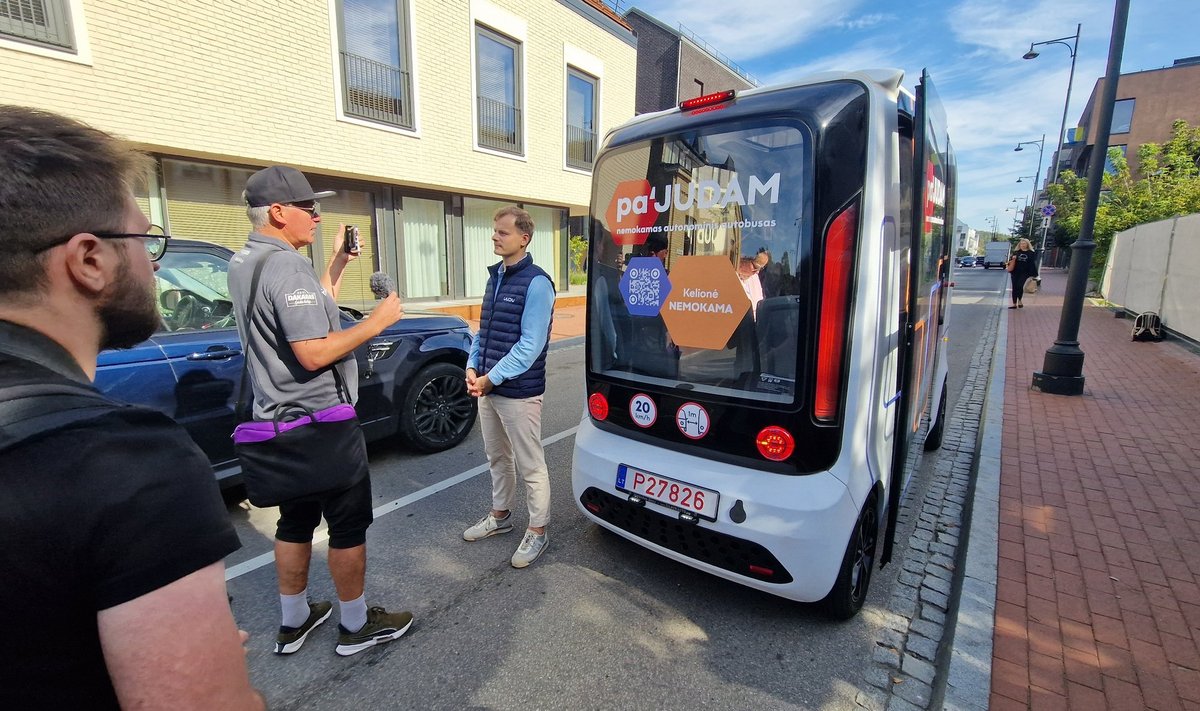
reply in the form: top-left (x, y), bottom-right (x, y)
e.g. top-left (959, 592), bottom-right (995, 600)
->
top-left (1046, 120), bottom-right (1200, 280)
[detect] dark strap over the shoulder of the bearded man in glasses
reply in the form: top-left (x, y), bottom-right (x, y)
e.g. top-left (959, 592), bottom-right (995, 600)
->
top-left (0, 383), bottom-right (121, 450)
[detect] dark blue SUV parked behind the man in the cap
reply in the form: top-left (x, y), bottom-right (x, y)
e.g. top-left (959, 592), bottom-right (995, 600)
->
top-left (96, 239), bottom-right (475, 488)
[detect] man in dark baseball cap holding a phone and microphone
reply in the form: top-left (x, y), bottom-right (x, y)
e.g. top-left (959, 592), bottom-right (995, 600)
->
top-left (229, 166), bottom-right (413, 656)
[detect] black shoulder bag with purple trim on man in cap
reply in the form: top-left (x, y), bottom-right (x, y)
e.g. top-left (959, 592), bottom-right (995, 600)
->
top-left (233, 253), bottom-right (368, 507)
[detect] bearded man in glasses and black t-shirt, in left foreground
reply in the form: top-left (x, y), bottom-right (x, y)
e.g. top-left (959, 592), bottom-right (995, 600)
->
top-left (0, 106), bottom-right (263, 710)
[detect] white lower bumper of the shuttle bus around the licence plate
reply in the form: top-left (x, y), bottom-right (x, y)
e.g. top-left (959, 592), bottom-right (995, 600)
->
top-left (571, 417), bottom-right (862, 602)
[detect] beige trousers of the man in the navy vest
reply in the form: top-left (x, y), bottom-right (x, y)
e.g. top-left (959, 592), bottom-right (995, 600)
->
top-left (479, 395), bottom-right (550, 528)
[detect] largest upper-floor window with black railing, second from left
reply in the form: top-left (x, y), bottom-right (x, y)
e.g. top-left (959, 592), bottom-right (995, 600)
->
top-left (338, 0), bottom-right (413, 129)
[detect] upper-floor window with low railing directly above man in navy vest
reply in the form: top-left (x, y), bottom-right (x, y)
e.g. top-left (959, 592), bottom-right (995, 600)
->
top-left (475, 26), bottom-right (523, 154)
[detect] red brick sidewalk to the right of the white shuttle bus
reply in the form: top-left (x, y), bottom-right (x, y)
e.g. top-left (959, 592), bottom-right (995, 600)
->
top-left (968, 270), bottom-right (1200, 711)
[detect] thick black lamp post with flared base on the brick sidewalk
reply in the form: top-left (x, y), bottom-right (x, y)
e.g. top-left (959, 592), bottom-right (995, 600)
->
top-left (1032, 0), bottom-right (1129, 395)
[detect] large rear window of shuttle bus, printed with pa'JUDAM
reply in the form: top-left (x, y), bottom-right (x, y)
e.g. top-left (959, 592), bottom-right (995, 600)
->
top-left (588, 119), bottom-right (812, 405)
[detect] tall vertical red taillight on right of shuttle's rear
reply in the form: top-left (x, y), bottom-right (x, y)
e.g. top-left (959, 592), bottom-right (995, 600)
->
top-left (812, 203), bottom-right (858, 422)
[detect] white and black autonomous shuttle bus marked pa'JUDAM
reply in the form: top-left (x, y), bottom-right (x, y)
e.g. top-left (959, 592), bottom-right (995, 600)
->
top-left (572, 71), bottom-right (955, 617)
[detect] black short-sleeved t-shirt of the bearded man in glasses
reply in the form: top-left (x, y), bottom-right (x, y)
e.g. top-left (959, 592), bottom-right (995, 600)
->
top-left (0, 369), bottom-right (241, 709)
